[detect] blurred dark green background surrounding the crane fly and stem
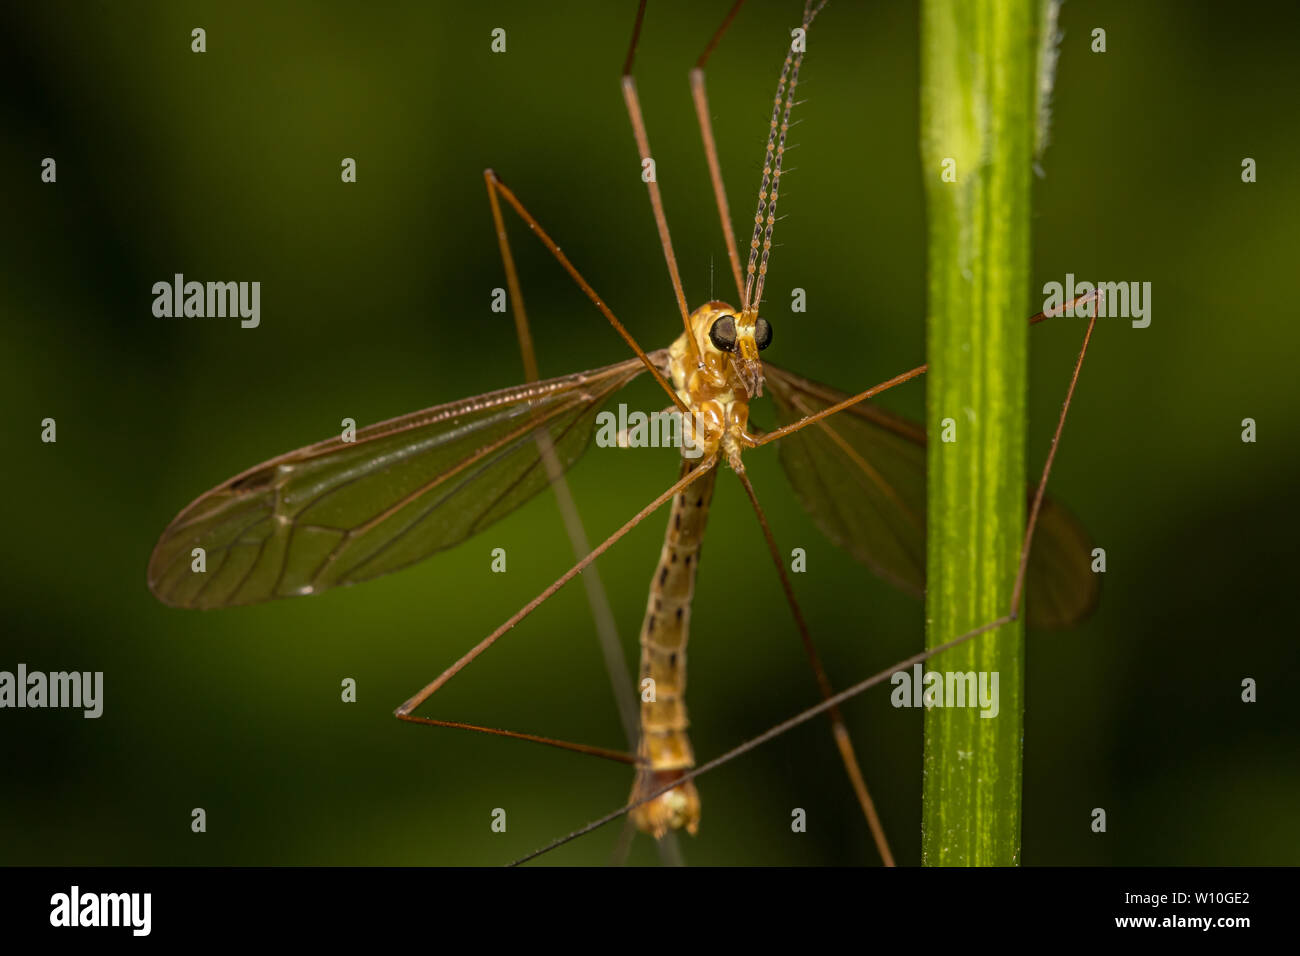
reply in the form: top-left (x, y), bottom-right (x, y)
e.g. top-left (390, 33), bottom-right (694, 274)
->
top-left (0, 0), bottom-right (1300, 864)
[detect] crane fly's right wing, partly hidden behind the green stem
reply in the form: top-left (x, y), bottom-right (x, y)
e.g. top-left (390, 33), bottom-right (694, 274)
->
top-left (763, 362), bottom-right (1100, 627)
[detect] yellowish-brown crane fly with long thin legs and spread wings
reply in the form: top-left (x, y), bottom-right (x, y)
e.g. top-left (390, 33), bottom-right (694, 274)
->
top-left (148, 0), bottom-right (1097, 864)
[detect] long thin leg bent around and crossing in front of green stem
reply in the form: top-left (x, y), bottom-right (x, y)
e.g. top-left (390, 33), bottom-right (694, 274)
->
top-left (512, 306), bottom-right (1097, 865)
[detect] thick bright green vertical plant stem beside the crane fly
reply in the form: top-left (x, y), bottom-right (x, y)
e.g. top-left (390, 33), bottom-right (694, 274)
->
top-left (922, 0), bottom-right (1040, 866)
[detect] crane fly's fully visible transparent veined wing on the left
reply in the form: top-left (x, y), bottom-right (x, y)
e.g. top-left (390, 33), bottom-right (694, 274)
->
top-left (148, 352), bottom-right (663, 607)
